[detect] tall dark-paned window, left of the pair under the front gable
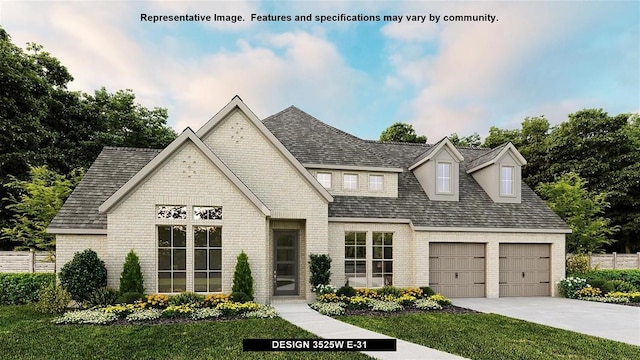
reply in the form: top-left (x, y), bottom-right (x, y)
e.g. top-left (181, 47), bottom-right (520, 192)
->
top-left (158, 225), bottom-right (187, 293)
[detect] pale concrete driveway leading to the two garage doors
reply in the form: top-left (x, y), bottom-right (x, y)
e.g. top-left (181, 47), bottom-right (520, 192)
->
top-left (452, 297), bottom-right (640, 345)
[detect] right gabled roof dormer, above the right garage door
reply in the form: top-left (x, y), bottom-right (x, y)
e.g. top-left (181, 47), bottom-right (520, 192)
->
top-left (467, 143), bottom-right (527, 203)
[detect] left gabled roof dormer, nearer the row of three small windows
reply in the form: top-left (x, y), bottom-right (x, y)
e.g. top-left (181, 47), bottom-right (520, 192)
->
top-left (409, 137), bottom-right (464, 201)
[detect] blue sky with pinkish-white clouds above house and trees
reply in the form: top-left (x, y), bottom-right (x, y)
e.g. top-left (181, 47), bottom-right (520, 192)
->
top-left (0, 0), bottom-right (640, 142)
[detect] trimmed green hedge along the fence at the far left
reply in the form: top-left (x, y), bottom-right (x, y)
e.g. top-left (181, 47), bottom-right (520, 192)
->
top-left (0, 273), bottom-right (56, 305)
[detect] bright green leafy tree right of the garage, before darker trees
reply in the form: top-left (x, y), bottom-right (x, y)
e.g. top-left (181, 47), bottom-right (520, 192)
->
top-left (537, 172), bottom-right (618, 254)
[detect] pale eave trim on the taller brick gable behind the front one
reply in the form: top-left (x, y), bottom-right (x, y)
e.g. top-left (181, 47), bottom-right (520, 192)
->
top-left (196, 95), bottom-right (333, 202)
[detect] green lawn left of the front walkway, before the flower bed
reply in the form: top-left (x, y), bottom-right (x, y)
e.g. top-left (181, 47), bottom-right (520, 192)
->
top-left (0, 305), bottom-right (369, 359)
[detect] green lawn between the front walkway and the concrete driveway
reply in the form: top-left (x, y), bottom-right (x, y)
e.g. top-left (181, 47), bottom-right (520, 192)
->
top-left (338, 313), bottom-right (640, 360)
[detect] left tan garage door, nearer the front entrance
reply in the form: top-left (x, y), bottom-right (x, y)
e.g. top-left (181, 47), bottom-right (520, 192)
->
top-left (429, 243), bottom-right (485, 297)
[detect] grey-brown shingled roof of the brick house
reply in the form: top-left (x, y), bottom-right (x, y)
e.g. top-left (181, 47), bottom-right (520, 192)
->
top-left (49, 106), bottom-right (568, 233)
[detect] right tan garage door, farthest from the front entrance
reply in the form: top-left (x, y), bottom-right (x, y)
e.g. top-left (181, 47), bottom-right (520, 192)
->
top-left (500, 244), bottom-right (551, 296)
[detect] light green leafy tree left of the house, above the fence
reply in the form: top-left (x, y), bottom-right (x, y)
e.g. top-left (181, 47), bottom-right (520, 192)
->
top-left (1, 166), bottom-right (82, 251)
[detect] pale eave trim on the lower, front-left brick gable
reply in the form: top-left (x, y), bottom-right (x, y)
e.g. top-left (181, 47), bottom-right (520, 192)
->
top-left (98, 128), bottom-right (271, 216)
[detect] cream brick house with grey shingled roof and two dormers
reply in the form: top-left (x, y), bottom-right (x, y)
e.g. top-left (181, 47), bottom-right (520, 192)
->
top-left (48, 96), bottom-right (570, 303)
